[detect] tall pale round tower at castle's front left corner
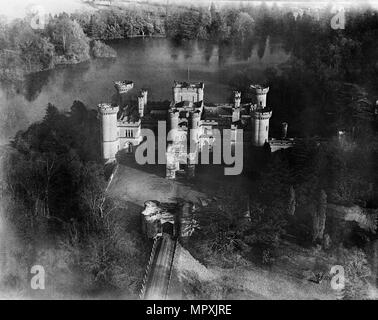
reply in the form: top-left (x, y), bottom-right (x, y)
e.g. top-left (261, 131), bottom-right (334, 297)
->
top-left (98, 103), bottom-right (119, 161)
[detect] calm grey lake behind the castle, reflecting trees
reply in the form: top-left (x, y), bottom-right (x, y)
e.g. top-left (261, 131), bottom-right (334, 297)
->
top-left (0, 38), bottom-right (290, 143)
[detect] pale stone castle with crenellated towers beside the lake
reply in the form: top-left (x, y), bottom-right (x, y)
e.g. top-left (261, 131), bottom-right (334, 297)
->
top-left (98, 81), bottom-right (292, 179)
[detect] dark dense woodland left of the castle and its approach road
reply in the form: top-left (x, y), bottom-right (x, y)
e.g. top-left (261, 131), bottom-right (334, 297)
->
top-left (1, 101), bottom-right (148, 298)
